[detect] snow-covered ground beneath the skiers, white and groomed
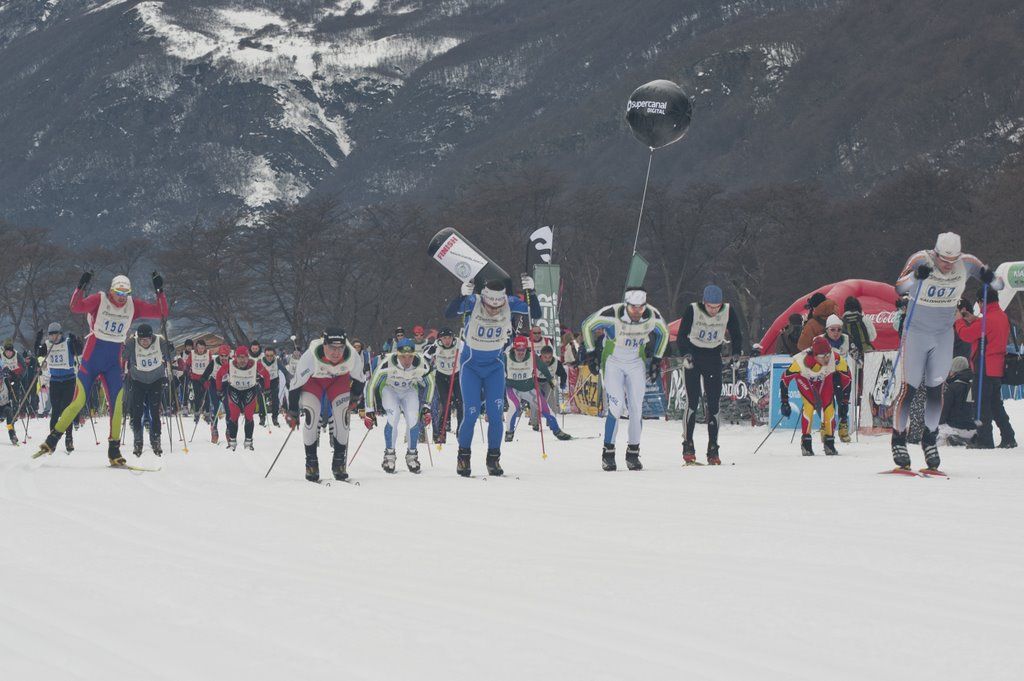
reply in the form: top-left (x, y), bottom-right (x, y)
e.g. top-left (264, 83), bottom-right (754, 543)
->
top-left (0, 405), bottom-right (1024, 681)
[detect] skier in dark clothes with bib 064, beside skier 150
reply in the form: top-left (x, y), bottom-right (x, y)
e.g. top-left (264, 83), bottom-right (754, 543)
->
top-left (121, 324), bottom-right (171, 457)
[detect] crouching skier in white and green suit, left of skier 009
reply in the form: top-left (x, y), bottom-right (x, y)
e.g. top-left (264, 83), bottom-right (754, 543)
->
top-left (362, 338), bottom-right (434, 473)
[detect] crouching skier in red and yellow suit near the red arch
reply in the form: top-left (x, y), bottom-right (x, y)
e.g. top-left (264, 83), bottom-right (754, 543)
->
top-left (778, 336), bottom-right (851, 457)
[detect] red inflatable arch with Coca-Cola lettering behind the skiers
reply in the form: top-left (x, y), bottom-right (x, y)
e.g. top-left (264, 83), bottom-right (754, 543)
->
top-left (761, 279), bottom-right (899, 354)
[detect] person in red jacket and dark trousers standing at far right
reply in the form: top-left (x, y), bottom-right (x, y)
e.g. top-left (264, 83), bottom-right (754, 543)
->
top-left (953, 284), bottom-right (1017, 450)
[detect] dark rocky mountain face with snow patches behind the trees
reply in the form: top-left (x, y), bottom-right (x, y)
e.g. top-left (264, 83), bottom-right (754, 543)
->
top-left (0, 0), bottom-right (1024, 241)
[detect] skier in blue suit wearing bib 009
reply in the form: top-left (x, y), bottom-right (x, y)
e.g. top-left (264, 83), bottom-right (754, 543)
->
top-left (444, 274), bottom-right (541, 477)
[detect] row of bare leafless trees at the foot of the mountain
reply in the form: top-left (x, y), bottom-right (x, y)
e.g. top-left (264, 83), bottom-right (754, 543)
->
top-left (0, 159), bottom-right (1024, 344)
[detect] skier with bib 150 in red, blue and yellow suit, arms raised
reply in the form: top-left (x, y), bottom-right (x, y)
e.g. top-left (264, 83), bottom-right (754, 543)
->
top-left (36, 272), bottom-right (168, 466)
